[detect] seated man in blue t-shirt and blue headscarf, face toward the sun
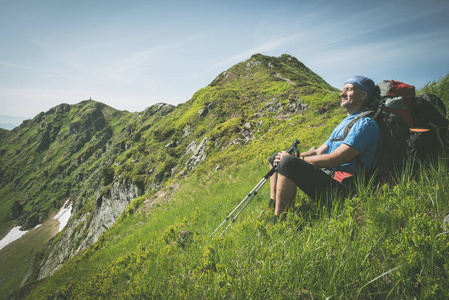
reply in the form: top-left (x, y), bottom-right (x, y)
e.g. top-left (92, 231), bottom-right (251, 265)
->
top-left (269, 76), bottom-right (379, 222)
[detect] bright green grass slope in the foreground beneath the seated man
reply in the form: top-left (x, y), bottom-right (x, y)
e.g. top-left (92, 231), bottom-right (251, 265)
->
top-left (19, 160), bottom-right (449, 299)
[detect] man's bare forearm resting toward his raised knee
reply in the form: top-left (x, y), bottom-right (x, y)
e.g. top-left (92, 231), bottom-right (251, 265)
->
top-left (301, 144), bottom-right (359, 169)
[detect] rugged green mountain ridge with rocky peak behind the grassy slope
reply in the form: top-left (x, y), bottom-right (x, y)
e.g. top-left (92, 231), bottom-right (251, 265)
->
top-left (0, 54), bottom-right (337, 296)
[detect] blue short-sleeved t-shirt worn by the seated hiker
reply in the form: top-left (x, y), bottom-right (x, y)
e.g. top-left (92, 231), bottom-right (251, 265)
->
top-left (325, 112), bottom-right (379, 171)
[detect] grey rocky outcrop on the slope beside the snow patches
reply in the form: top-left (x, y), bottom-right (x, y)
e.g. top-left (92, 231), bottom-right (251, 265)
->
top-left (38, 180), bottom-right (144, 279)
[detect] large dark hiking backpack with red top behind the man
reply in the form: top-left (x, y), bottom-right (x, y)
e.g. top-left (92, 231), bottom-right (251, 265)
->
top-left (344, 80), bottom-right (449, 183)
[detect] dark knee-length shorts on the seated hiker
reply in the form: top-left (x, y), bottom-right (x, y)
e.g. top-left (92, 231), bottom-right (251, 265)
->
top-left (268, 153), bottom-right (353, 200)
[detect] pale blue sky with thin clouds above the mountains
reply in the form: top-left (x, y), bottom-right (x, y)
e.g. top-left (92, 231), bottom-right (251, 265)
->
top-left (0, 0), bottom-right (449, 118)
